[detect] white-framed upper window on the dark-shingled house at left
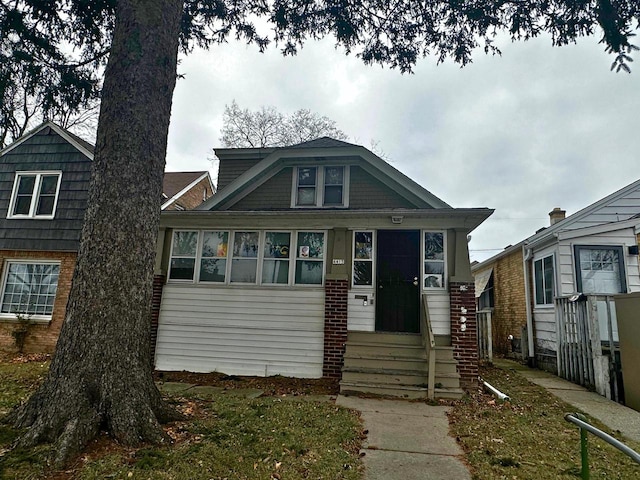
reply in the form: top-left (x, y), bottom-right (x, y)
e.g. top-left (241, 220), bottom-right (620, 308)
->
top-left (7, 172), bottom-right (62, 219)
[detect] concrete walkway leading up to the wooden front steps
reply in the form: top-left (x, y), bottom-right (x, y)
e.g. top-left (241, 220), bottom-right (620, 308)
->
top-left (336, 395), bottom-right (471, 480)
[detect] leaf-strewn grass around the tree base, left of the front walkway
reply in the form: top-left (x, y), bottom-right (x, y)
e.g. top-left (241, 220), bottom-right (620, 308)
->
top-left (0, 362), bottom-right (362, 480)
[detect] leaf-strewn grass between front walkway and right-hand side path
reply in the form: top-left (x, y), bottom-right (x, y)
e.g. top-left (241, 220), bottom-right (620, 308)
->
top-left (449, 367), bottom-right (640, 480)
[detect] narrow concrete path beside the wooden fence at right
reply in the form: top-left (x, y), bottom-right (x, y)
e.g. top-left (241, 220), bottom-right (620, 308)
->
top-left (494, 359), bottom-right (640, 442)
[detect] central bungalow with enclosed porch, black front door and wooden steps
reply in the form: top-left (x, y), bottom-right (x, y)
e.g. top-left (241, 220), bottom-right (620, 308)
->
top-left (154, 137), bottom-right (492, 396)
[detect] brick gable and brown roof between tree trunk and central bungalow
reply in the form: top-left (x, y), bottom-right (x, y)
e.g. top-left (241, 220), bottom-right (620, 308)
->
top-left (161, 171), bottom-right (216, 210)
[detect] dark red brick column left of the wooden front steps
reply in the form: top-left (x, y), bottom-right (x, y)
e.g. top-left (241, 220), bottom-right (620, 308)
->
top-left (322, 279), bottom-right (349, 379)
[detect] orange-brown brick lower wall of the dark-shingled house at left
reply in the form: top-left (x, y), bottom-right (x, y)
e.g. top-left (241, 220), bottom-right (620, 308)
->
top-left (0, 250), bottom-right (77, 353)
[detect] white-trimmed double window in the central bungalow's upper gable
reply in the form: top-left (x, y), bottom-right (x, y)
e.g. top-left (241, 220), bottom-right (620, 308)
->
top-left (291, 166), bottom-right (349, 208)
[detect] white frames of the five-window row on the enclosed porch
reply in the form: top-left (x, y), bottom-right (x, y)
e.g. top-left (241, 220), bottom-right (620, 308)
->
top-left (166, 228), bottom-right (328, 288)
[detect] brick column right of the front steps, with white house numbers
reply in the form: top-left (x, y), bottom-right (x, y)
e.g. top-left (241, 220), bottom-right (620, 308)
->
top-left (449, 282), bottom-right (478, 390)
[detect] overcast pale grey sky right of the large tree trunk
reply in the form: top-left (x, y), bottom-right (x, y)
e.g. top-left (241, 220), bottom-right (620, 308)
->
top-left (167, 31), bottom-right (640, 260)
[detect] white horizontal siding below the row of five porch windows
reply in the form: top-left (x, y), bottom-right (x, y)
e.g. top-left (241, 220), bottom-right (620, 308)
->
top-left (156, 284), bottom-right (324, 378)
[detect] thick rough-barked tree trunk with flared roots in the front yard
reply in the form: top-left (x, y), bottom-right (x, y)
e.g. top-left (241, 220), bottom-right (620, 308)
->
top-left (10, 0), bottom-right (182, 464)
